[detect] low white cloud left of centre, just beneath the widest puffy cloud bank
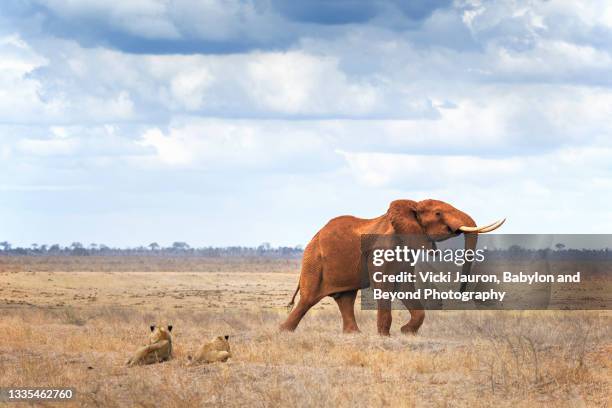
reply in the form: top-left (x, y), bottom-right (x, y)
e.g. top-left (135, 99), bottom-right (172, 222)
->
top-left (133, 117), bottom-right (328, 173)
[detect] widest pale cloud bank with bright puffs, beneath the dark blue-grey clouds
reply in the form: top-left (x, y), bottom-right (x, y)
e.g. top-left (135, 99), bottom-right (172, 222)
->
top-left (5, 41), bottom-right (412, 122)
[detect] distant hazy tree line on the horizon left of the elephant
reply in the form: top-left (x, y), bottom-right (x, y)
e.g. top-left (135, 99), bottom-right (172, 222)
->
top-left (0, 241), bottom-right (303, 258)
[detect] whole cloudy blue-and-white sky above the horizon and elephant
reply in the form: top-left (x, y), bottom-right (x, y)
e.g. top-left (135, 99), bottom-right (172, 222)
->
top-left (0, 0), bottom-right (612, 246)
